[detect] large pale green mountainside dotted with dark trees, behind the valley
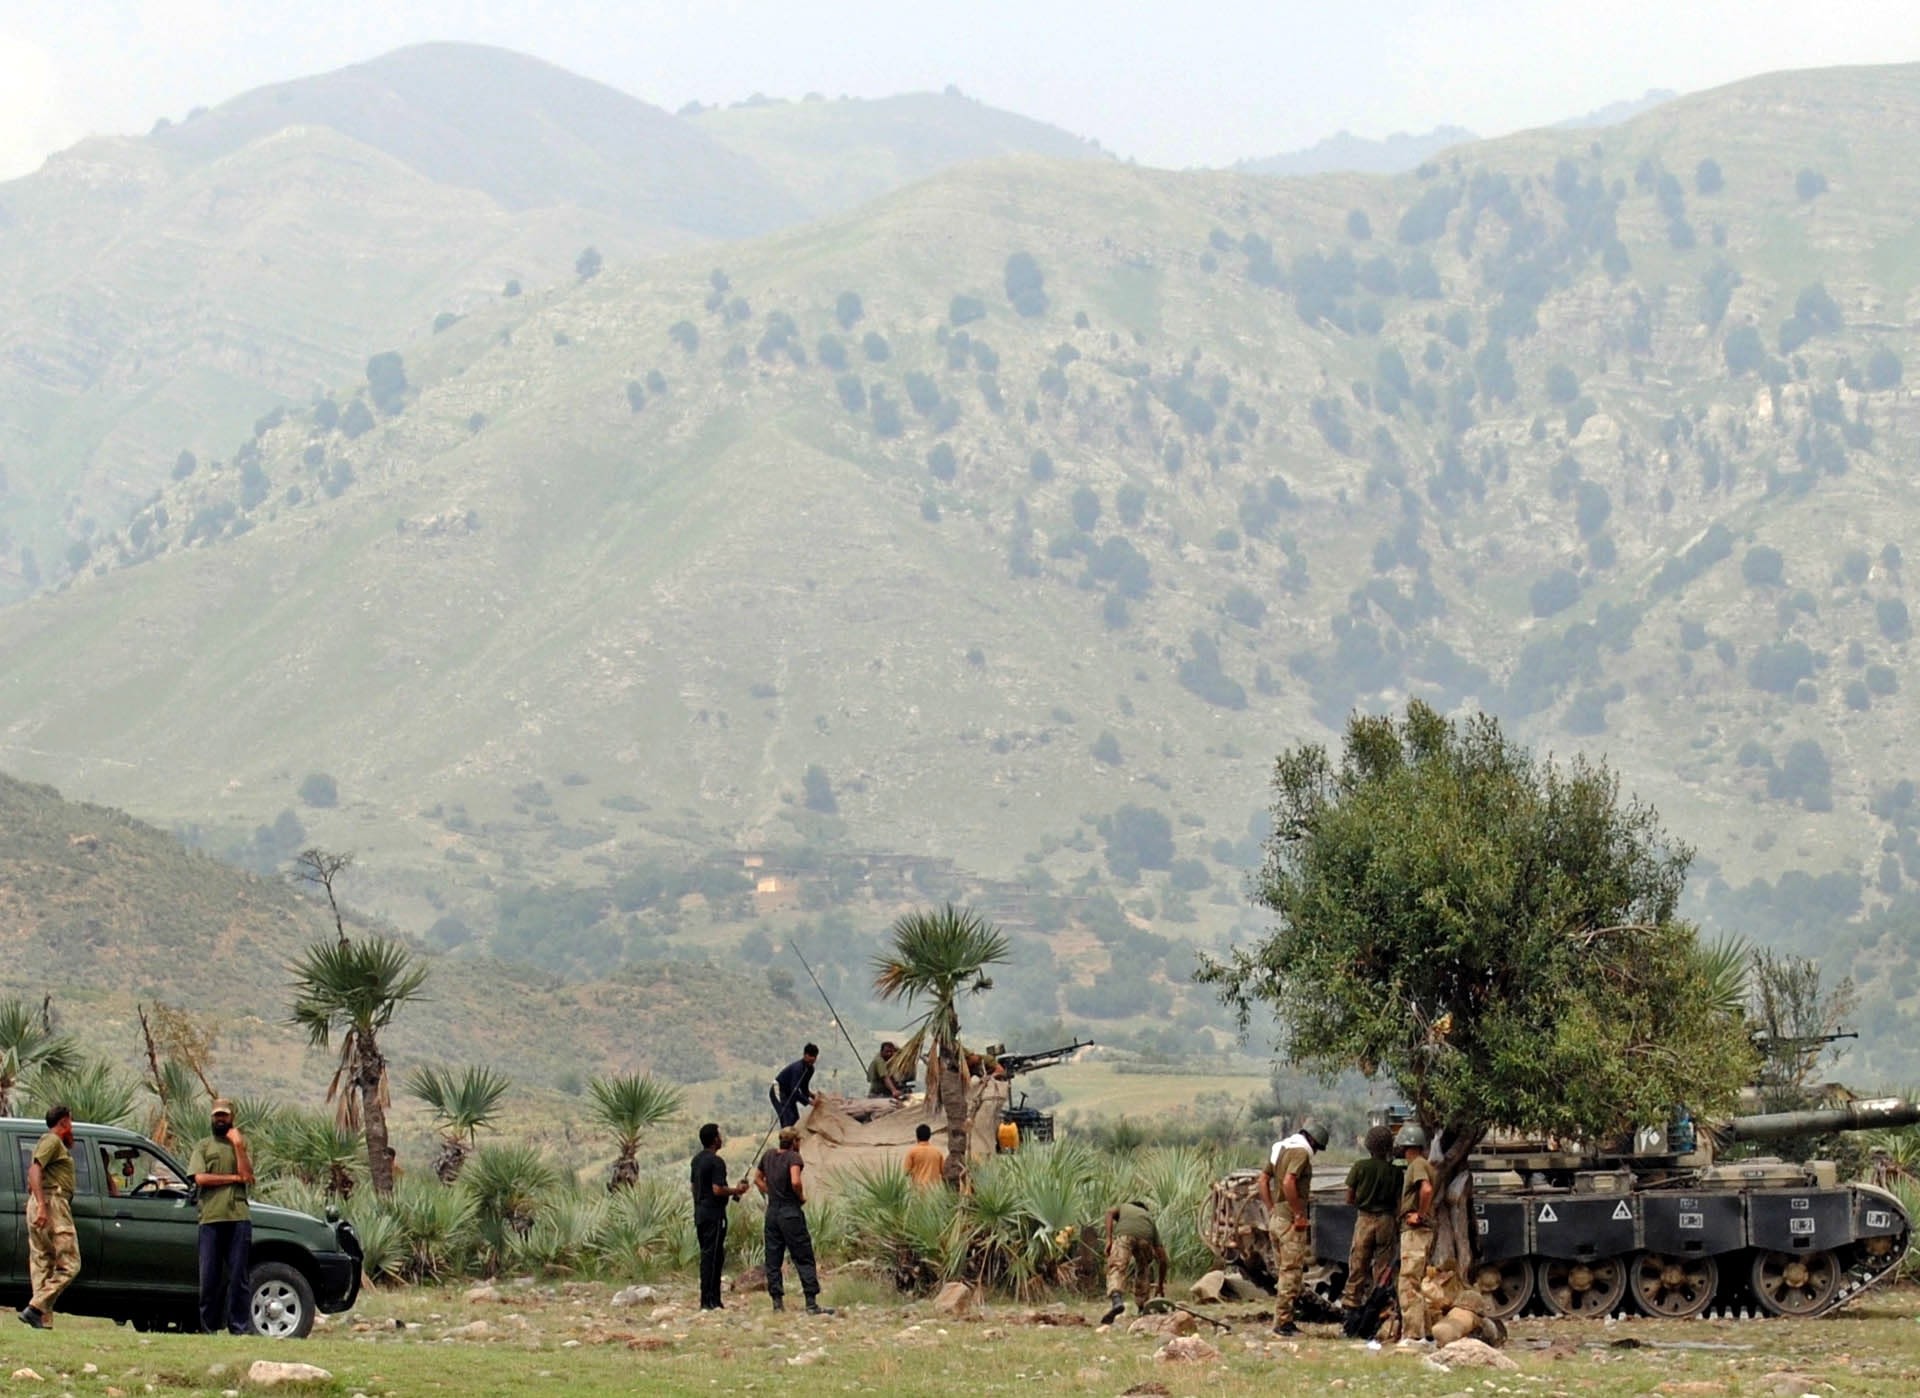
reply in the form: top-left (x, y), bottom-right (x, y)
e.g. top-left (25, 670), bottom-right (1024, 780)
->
top-left (11, 67), bottom-right (1920, 1067)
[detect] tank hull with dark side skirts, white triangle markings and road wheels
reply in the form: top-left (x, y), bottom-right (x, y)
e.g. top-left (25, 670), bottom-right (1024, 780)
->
top-left (1200, 1169), bottom-right (1912, 1319)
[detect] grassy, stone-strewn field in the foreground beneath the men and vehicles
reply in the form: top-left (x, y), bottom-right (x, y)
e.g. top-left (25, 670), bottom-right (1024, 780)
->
top-left (0, 1277), bottom-right (1920, 1398)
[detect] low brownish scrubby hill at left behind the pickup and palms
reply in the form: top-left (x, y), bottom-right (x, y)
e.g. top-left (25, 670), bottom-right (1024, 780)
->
top-left (0, 776), bottom-right (814, 1102)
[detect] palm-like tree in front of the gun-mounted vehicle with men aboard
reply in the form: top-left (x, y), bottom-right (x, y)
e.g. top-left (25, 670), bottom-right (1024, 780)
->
top-left (874, 903), bottom-right (1008, 1185)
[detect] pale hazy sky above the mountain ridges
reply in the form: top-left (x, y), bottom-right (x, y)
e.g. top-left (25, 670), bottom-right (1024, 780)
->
top-left (0, 0), bottom-right (1920, 177)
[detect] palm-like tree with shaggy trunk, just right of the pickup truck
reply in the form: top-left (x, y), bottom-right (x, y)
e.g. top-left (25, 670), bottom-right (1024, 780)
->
top-left (292, 935), bottom-right (426, 1194)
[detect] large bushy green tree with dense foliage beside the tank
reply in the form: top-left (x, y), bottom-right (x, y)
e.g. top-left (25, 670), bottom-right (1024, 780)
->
top-left (1200, 701), bottom-right (1751, 1260)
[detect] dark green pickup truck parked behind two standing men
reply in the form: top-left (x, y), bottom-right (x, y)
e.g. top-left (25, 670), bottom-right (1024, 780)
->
top-left (0, 1118), bottom-right (361, 1338)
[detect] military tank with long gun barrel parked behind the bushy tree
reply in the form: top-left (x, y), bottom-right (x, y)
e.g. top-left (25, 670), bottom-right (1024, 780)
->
top-left (1200, 1098), bottom-right (1920, 1319)
